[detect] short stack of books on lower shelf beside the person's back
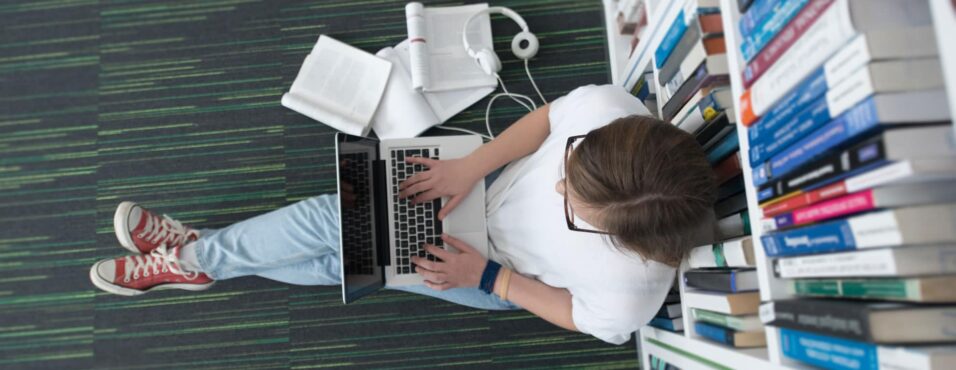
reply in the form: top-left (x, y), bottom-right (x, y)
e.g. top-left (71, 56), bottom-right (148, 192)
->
top-left (683, 236), bottom-right (766, 347)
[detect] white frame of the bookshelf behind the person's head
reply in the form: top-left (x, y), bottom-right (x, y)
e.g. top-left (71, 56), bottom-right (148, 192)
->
top-left (604, 0), bottom-right (956, 369)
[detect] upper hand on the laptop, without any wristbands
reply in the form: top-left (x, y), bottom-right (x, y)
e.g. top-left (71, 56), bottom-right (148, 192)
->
top-left (399, 157), bottom-right (482, 219)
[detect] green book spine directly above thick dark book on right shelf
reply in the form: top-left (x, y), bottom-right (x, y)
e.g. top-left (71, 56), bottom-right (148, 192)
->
top-left (789, 279), bottom-right (921, 301)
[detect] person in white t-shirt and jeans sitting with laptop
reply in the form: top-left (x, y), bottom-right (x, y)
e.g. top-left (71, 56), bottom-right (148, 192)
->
top-left (90, 86), bottom-right (716, 344)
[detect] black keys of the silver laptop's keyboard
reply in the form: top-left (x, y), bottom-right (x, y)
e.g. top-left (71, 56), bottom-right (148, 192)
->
top-left (391, 148), bottom-right (443, 274)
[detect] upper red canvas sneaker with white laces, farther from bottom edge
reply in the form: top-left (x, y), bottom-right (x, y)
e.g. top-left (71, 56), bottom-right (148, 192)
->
top-left (113, 202), bottom-right (199, 253)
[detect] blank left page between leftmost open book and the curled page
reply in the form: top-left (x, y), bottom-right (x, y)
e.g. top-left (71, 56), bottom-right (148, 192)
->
top-left (372, 46), bottom-right (441, 139)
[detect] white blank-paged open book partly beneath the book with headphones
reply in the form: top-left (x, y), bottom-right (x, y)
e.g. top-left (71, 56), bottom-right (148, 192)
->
top-left (372, 40), bottom-right (495, 139)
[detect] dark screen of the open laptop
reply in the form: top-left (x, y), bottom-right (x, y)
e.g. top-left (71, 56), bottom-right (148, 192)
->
top-left (339, 153), bottom-right (375, 275)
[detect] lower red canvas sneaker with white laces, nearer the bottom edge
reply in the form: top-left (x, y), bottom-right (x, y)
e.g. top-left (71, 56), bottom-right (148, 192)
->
top-left (90, 246), bottom-right (214, 296)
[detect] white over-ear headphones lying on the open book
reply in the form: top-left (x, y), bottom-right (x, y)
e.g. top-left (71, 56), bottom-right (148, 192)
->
top-left (461, 6), bottom-right (538, 75)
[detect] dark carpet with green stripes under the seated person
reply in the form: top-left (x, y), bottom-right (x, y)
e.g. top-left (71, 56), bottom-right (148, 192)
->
top-left (0, 0), bottom-right (637, 370)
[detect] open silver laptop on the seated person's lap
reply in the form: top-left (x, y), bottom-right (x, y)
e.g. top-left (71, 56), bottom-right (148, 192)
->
top-left (335, 133), bottom-right (488, 303)
